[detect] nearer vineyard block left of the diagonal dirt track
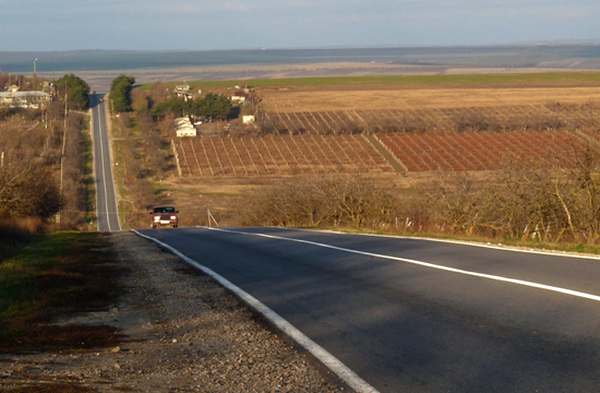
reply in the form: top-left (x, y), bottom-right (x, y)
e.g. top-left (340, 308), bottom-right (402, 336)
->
top-left (176, 135), bottom-right (394, 176)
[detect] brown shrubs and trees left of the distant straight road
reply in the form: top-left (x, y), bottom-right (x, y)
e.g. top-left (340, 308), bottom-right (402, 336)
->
top-left (0, 75), bottom-right (94, 240)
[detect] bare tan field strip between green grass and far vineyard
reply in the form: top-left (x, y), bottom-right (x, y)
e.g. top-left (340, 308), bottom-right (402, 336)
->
top-left (260, 87), bottom-right (600, 112)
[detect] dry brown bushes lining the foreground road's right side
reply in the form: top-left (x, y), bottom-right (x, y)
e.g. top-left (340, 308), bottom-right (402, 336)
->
top-left (240, 149), bottom-right (600, 253)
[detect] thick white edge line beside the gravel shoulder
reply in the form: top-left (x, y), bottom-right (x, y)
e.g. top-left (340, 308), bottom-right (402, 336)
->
top-left (132, 229), bottom-right (379, 393)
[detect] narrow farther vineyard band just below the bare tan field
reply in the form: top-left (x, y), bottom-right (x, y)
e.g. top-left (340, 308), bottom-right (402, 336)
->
top-left (261, 104), bottom-right (600, 134)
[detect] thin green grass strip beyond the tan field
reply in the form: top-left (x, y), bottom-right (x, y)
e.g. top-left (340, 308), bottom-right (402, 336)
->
top-left (141, 71), bottom-right (600, 90)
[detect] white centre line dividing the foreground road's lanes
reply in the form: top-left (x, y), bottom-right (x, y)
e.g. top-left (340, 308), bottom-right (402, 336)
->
top-left (202, 227), bottom-right (600, 302)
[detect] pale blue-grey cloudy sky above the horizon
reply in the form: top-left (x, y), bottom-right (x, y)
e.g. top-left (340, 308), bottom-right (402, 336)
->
top-left (0, 0), bottom-right (600, 51)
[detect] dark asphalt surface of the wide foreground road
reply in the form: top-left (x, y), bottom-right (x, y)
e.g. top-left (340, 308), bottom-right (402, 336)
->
top-left (143, 228), bottom-right (600, 393)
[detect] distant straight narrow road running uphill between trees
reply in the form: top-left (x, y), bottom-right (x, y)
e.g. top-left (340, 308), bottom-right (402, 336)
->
top-left (90, 95), bottom-right (121, 232)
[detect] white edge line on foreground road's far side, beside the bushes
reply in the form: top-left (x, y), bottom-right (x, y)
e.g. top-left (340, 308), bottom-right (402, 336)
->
top-left (296, 227), bottom-right (600, 262)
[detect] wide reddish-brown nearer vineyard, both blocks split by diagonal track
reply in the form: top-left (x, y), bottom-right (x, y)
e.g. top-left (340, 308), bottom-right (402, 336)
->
top-left (173, 131), bottom-right (597, 177)
